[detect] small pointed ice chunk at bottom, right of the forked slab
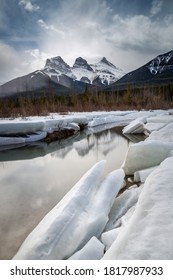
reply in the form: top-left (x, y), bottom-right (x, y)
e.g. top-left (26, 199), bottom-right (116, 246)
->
top-left (69, 236), bottom-right (105, 260)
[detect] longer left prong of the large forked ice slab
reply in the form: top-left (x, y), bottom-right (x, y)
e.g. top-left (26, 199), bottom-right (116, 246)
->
top-left (14, 161), bottom-right (105, 259)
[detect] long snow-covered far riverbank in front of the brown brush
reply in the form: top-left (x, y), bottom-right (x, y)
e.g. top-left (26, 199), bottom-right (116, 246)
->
top-left (0, 110), bottom-right (164, 146)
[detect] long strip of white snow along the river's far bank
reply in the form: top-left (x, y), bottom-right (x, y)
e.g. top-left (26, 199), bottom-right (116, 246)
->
top-left (0, 111), bottom-right (168, 145)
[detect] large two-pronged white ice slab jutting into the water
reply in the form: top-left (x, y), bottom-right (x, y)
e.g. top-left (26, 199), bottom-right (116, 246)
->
top-left (14, 161), bottom-right (124, 259)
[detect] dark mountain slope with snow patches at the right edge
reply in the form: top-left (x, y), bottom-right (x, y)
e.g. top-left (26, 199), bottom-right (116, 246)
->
top-left (107, 50), bottom-right (173, 90)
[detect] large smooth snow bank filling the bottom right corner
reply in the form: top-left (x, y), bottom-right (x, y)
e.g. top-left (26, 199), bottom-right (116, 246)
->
top-left (103, 157), bottom-right (173, 260)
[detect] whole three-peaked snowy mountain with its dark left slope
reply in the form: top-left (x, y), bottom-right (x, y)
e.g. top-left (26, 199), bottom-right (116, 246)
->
top-left (0, 56), bottom-right (124, 97)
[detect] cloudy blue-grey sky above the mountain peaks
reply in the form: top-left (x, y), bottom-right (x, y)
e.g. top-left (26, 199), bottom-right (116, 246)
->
top-left (0, 0), bottom-right (173, 83)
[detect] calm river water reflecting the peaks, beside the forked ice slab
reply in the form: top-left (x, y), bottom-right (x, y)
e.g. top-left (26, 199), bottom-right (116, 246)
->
top-left (0, 128), bottom-right (129, 259)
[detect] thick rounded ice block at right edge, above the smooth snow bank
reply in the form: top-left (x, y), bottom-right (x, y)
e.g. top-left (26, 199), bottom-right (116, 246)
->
top-left (122, 140), bottom-right (173, 175)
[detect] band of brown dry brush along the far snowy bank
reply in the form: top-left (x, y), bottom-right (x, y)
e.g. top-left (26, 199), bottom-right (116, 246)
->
top-left (0, 88), bottom-right (173, 118)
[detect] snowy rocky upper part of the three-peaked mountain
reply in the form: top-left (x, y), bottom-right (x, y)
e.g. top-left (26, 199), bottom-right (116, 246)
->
top-left (43, 56), bottom-right (125, 85)
